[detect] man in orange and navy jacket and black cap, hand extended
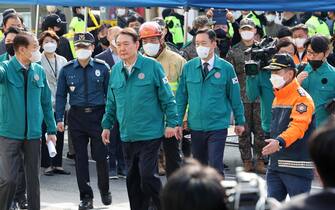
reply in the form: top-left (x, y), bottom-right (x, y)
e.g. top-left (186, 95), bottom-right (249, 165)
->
top-left (263, 54), bottom-right (315, 201)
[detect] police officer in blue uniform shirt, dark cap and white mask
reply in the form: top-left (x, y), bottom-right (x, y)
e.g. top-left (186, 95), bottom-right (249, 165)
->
top-left (56, 33), bottom-right (112, 210)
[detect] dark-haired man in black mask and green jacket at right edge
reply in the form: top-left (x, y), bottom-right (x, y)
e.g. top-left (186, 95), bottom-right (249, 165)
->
top-left (297, 36), bottom-right (335, 126)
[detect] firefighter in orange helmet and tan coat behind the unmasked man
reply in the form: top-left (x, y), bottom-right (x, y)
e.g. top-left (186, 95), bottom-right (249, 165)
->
top-left (140, 22), bottom-right (186, 177)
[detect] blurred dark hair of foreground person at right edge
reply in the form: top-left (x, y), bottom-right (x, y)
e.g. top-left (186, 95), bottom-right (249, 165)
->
top-left (309, 117), bottom-right (335, 187)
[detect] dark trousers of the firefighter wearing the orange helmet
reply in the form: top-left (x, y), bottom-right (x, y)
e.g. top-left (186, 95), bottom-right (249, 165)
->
top-left (163, 137), bottom-right (182, 177)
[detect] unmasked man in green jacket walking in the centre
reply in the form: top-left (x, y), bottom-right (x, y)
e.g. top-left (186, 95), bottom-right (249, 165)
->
top-left (102, 28), bottom-right (180, 210)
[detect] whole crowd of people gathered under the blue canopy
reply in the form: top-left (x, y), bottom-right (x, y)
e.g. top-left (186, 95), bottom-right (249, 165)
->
top-left (0, 6), bottom-right (335, 210)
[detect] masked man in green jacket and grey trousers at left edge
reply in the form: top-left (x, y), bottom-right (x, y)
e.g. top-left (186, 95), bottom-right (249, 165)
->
top-left (0, 32), bottom-right (56, 210)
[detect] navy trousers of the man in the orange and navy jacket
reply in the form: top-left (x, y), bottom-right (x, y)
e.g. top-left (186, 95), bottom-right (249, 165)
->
top-left (266, 169), bottom-right (312, 202)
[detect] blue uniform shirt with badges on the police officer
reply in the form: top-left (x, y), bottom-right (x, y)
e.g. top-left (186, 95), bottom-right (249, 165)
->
top-left (56, 59), bottom-right (110, 122)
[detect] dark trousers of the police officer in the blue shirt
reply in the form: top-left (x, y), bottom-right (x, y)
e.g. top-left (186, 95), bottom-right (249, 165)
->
top-left (68, 108), bottom-right (109, 200)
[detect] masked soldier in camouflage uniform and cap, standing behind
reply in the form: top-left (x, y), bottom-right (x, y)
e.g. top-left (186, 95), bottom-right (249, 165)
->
top-left (227, 18), bottom-right (266, 173)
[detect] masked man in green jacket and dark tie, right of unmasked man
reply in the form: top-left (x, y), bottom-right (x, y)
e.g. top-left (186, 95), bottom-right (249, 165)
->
top-left (176, 29), bottom-right (245, 174)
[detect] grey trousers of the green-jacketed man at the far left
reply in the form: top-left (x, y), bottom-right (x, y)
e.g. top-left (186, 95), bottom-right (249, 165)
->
top-left (0, 137), bottom-right (40, 210)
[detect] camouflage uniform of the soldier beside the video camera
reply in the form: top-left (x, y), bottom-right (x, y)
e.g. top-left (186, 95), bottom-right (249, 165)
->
top-left (227, 42), bottom-right (265, 161)
